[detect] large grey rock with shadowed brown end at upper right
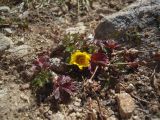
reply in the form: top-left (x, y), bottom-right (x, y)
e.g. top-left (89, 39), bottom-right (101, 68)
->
top-left (95, 0), bottom-right (160, 39)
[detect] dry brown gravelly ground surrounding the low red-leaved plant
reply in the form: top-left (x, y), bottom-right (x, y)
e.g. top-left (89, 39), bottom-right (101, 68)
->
top-left (0, 0), bottom-right (160, 120)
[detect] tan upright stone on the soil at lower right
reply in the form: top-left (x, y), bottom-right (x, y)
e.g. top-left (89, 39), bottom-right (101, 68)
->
top-left (116, 92), bottom-right (135, 118)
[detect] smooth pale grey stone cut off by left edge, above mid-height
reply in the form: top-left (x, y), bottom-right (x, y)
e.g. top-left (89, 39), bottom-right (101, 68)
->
top-left (0, 33), bottom-right (13, 54)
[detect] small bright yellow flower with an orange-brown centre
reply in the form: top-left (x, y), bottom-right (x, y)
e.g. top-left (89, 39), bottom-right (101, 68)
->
top-left (70, 50), bottom-right (91, 70)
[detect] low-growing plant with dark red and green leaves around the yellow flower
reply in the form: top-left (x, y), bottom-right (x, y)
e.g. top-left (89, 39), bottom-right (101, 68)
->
top-left (32, 34), bottom-right (144, 106)
